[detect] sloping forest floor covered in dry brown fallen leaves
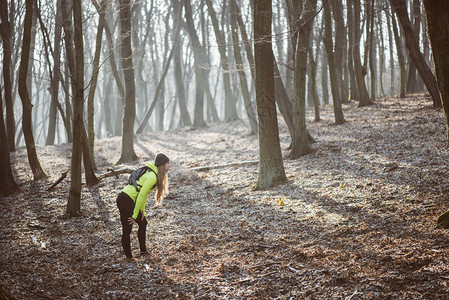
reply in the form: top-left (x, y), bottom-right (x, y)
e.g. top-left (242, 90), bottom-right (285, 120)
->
top-left (0, 95), bottom-right (449, 300)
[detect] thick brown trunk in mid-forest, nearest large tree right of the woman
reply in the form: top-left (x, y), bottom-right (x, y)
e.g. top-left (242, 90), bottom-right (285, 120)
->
top-left (253, 0), bottom-right (286, 189)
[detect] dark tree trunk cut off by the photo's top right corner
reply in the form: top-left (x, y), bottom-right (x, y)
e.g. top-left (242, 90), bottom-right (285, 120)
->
top-left (424, 0), bottom-right (449, 143)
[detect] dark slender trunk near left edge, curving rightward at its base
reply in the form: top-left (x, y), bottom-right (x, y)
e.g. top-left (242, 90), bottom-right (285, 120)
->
top-left (19, 1), bottom-right (47, 180)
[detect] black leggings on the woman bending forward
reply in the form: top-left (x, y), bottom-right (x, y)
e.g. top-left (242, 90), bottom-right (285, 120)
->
top-left (117, 192), bottom-right (148, 258)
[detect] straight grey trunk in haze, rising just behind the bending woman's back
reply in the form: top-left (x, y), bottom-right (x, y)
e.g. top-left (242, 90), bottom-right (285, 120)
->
top-left (117, 0), bottom-right (137, 164)
